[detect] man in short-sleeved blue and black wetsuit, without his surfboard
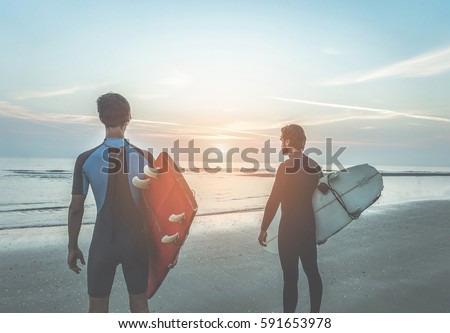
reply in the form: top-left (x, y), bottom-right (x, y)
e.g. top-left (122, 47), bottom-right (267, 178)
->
top-left (67, 93), bottom-right (151, 312)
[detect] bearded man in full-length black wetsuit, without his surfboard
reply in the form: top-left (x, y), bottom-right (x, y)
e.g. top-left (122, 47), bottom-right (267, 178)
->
top-left (258, 124), bottom-right (322, 312)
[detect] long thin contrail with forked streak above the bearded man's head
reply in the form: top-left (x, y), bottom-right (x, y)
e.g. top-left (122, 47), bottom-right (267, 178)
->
top-left (264, 96), bottom-right (450, 125)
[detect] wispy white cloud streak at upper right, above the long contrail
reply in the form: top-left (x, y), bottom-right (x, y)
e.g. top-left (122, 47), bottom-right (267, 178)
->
top-left (325, 47), bottom-right (450, 85)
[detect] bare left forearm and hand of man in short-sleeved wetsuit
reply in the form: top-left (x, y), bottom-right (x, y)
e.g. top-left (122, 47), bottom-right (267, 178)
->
top-left (67, 195), bottom-right (86, 274)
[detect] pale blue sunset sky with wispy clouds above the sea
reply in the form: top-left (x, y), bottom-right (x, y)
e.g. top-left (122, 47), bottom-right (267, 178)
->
top-left (0, 0), bottom-right (450, 167)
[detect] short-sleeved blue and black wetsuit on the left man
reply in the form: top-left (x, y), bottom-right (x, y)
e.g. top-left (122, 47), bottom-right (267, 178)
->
top-left (72, 138), bottom-right (149, 297)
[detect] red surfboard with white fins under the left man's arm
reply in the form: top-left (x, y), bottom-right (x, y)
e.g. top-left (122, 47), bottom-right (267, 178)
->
top-left (133, 152), bottom-right (198, 298)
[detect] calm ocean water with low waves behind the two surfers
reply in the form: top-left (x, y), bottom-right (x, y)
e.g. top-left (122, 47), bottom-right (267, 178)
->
top-left (0, 158), bottom-right (450, 229)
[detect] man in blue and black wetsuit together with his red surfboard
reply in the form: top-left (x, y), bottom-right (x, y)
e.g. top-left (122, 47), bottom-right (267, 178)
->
top-left (67, 93), bottom-right (197, 312)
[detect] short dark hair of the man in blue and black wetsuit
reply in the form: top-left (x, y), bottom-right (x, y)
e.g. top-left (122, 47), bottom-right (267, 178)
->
top-left (97, 93), bottom-right (130, 127)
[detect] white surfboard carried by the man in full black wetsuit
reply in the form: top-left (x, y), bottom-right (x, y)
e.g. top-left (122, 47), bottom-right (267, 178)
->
top-left (265, 164), bottom-right (383, 254)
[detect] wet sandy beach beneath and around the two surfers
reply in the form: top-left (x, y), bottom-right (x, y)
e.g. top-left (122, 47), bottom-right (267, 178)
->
top-left (0, 201), bottom-right (450, 313)
